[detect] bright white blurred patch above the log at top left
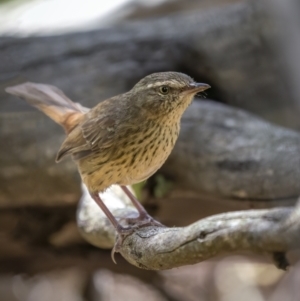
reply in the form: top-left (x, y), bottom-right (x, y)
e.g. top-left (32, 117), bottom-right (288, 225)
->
top-left (0, 0), bottom-right (239, 36)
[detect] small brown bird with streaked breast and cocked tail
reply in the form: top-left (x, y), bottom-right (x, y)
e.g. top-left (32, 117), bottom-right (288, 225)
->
top-left (6, 72), bottom-right (210, 243)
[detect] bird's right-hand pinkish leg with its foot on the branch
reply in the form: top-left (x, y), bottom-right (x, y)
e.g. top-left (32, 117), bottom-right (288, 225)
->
top-left (121, 186), bottom-right (163, 227)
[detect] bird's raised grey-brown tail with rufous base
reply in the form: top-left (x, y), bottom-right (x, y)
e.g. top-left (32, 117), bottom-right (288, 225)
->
top-left (5, 82), bottom-right (89, 133)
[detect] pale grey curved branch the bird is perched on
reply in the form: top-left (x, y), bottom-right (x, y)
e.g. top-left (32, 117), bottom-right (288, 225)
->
top-left (77, 187), bottom-right (300, 270)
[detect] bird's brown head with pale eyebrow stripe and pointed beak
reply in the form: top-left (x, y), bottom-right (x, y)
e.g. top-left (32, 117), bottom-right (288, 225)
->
top-left (130, 72), bottom-right (210, 117)
